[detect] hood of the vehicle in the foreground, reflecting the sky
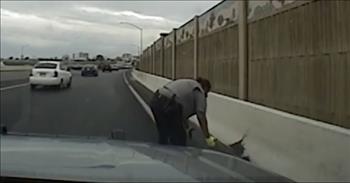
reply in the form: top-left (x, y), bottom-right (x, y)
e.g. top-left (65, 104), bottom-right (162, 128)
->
top-left (0, 135), bottom-right (292, 182)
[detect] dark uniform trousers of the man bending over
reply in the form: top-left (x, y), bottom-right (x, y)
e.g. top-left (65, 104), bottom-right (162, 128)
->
top-left (150, 91), bottom-right (186, 146)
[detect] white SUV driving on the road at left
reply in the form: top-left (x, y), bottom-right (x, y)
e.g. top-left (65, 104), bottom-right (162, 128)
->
top-left (29, 61), bottom-right (72, 88)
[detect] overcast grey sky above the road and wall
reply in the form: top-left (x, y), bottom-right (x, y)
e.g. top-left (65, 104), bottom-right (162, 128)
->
top-left (1, 1), bottom-right (219, 58)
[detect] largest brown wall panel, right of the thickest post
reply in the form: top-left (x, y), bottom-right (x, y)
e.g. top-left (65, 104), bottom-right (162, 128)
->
top-left (249, 1), bottom-right (350, 128)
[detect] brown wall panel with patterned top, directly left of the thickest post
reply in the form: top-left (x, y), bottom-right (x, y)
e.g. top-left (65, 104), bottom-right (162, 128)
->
top-left (198, 1), bottom-right (238, 97)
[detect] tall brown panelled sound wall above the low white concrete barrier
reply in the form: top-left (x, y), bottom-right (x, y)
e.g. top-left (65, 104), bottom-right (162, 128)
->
top-left (140, 0), bottom-right (350, 128)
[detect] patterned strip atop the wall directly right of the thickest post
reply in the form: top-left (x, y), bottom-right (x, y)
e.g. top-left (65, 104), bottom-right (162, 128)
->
top-left (248, 0), bottom-right (310, 20)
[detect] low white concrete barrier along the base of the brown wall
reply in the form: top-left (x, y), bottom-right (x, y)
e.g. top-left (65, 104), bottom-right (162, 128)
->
top-left (133, 71), bottom-right (350, 182)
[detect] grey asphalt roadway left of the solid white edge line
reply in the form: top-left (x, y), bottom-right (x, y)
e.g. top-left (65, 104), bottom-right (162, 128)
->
top-left (0, 71), bottom-right (157, 142)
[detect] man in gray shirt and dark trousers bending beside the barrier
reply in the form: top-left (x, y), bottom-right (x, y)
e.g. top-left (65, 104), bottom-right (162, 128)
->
top-left (150, 78), bottom-right (216, 147)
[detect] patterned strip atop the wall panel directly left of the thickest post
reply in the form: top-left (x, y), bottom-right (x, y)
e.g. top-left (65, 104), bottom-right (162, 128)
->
top-left (198, 0), bottom-right (238, 37)
